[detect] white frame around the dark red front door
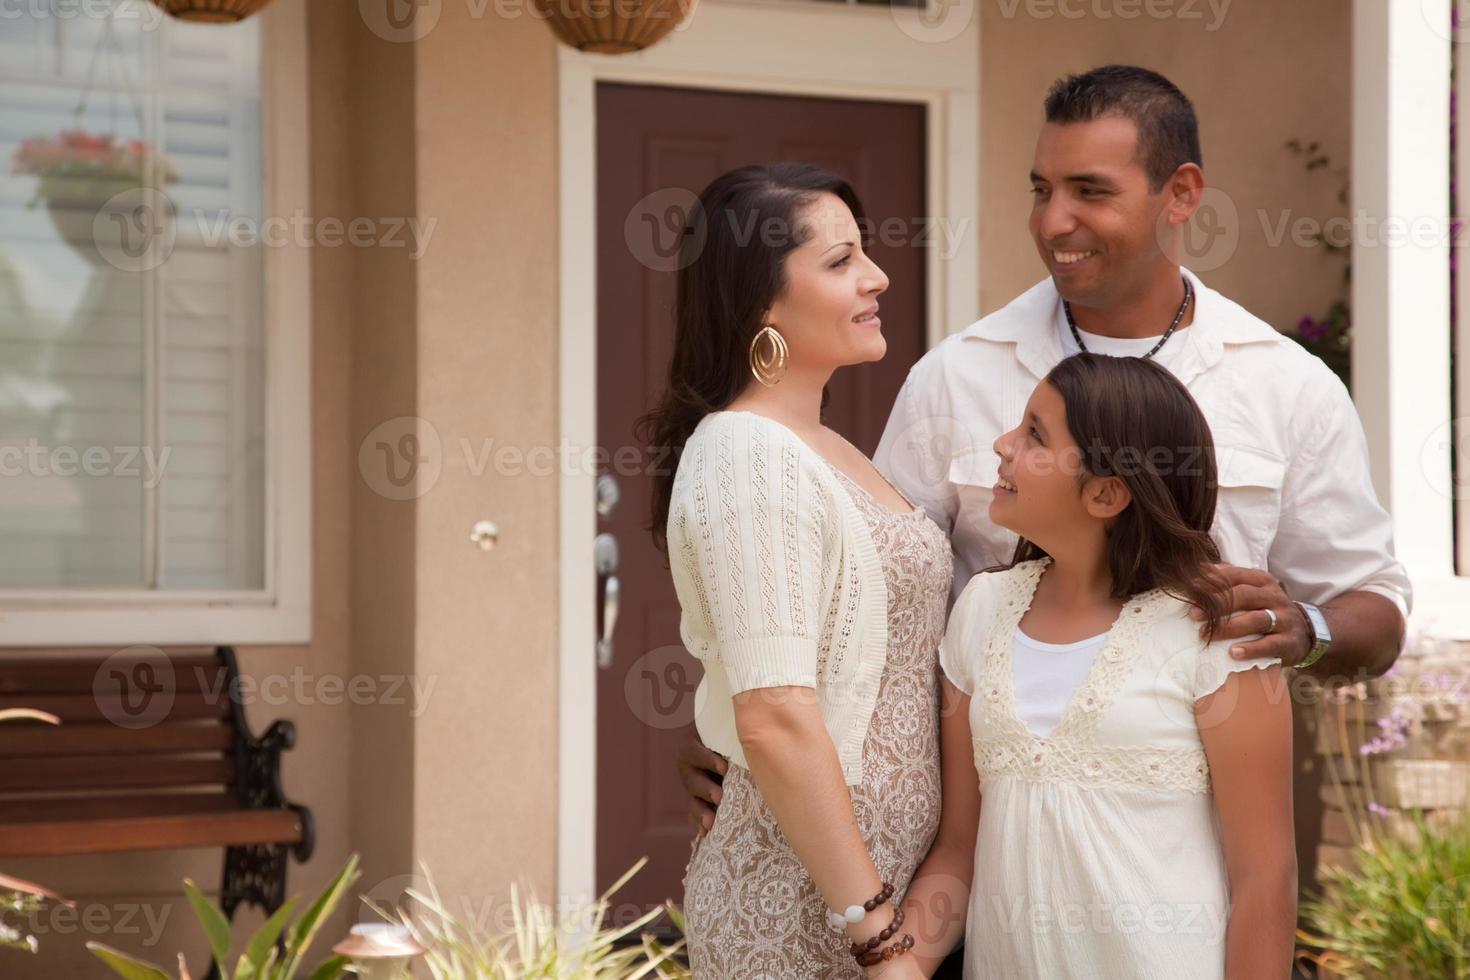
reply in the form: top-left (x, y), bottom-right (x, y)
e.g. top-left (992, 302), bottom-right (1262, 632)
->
top-left (557, 0), bottom-right (980, 901)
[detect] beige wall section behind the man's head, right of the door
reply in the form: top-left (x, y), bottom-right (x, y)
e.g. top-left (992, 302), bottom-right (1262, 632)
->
top-left (979, 0), bottom-right (1352, 329)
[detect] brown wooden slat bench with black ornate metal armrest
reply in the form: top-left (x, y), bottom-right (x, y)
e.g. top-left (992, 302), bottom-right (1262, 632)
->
top-left (0, 646), bottom-right (313, 918)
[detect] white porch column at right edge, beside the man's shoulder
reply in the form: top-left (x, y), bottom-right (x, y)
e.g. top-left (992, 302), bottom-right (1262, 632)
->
top-left (1351, 0), bottom-right (1470, 641)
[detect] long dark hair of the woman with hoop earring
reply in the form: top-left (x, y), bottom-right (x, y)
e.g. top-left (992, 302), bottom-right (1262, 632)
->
top-left (637, 163), bottom-right (864, 551)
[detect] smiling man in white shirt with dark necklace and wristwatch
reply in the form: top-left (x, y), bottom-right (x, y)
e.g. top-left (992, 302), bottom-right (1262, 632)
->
top-left (679, 65), bottom-right (1411, 975)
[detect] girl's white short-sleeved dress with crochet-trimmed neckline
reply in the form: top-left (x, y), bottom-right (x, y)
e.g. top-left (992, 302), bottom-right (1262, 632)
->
top-left (939, 558), bottom-right (1280, 980)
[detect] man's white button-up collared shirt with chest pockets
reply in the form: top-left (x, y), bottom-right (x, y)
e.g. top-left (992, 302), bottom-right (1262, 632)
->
top-left (873, 270), bottom-right (1413, 617)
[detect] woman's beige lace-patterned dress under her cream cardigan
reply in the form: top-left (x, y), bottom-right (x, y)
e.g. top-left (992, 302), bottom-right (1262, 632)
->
top-left (684, 467), bottom-right (954, 980)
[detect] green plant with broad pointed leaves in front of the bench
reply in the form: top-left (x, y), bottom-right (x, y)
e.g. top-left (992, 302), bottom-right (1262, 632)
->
top-left (87, 854), bottom-right (359, 980)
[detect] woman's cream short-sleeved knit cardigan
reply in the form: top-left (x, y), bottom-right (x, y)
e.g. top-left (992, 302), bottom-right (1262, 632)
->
top-left (667, 411), bottom-right (888, 785)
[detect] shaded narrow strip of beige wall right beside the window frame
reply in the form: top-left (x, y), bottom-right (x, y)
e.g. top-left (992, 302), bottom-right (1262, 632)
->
top-left (335, 4), bottom-right (420, 916)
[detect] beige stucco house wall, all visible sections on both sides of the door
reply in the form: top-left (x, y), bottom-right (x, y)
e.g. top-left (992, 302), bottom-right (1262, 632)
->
top-left (4, 0), bottom-right (1349, 977)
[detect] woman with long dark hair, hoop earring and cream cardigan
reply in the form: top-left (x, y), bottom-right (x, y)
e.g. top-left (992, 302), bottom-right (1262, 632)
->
top-left (644, 163), bottom-right (953, 980)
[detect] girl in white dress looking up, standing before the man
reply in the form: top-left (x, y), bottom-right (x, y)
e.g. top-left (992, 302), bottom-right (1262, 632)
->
top-left (906, 354), bottom-right (1297, 980)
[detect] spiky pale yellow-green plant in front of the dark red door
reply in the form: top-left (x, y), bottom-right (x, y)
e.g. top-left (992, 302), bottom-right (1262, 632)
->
top-left (365, 858), bottom-right (691, 980)
